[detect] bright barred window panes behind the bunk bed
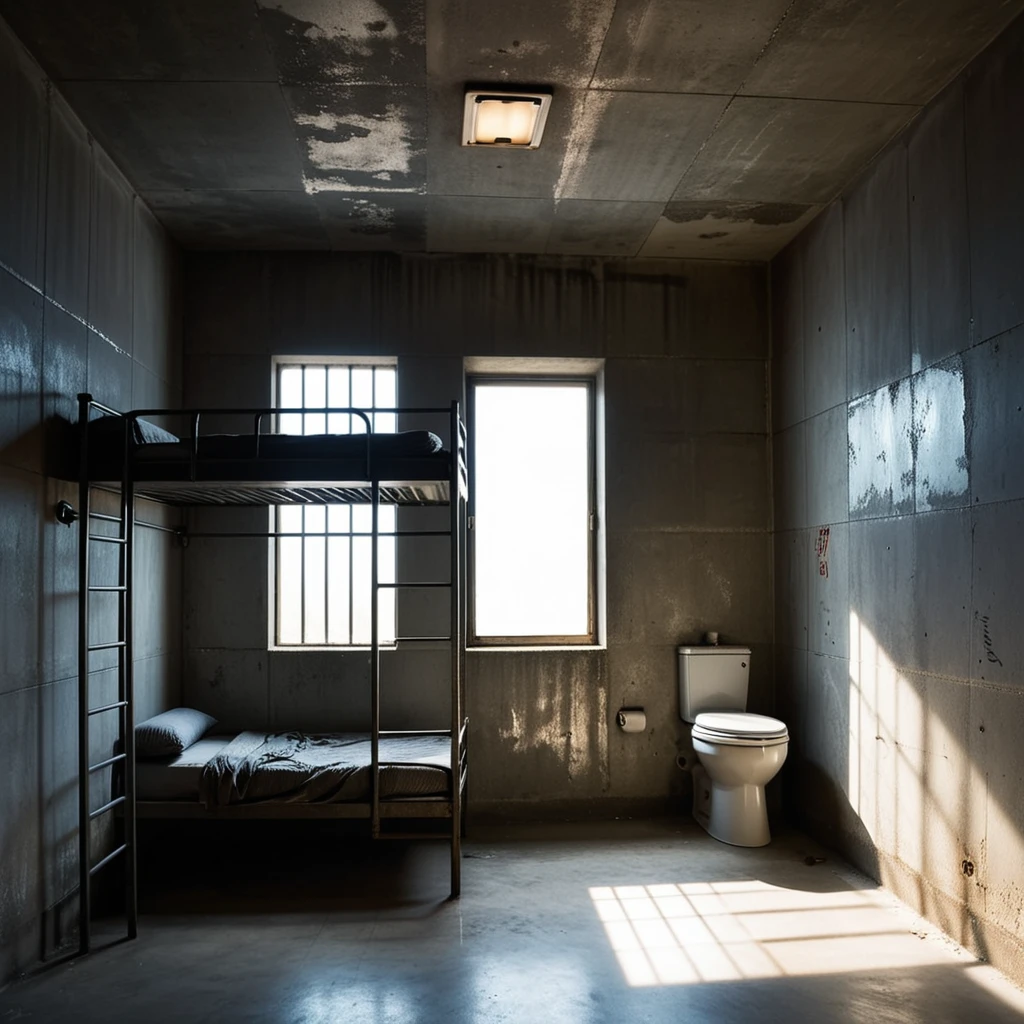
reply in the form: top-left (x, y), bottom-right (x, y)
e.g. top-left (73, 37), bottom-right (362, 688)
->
top-left (274, 362), bottom-right (397, 647)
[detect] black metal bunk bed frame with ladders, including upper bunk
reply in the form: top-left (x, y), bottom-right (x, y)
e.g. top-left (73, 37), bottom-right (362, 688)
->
top-left (74, 394), bottom-right (468, 953)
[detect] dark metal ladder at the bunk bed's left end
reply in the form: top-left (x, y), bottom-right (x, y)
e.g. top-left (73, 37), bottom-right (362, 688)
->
top-left (78, 394), bottom-right (138, 954)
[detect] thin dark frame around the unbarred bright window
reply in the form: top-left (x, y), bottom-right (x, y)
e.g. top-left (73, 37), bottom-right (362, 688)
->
top-left (466, 373), bottom-right (599, 648)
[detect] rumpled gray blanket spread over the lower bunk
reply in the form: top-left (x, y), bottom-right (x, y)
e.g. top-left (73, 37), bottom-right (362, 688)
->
top-left (200, 732), bottom-right (452, 808)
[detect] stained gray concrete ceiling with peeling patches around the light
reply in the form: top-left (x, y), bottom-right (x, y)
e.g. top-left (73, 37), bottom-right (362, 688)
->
top-left (0, 0), bottom-right (1024, 260)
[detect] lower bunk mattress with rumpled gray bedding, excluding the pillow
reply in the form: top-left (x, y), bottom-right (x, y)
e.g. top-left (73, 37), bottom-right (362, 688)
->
top-left (135, 732), bottom-right (452, 807)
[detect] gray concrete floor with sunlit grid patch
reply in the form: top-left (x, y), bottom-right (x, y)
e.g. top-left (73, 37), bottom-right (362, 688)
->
top-left (0, 820), bottom-right (1024, 1024)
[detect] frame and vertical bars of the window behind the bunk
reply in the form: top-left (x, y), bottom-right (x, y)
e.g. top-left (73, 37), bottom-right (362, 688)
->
top-left (267, 355), bottom-right (398, 651)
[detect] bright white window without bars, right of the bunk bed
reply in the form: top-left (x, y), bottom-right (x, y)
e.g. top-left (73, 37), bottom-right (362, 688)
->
top-left (470, 377), bottom-right (595, 644)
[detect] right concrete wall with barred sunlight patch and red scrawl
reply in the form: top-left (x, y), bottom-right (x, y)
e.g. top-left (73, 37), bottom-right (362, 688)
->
top-left (771, 22), bottom-right (1024, 979)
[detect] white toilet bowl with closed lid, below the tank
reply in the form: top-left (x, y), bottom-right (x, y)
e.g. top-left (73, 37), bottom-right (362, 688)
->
top-left (690, 712), bottom-right (790, 846)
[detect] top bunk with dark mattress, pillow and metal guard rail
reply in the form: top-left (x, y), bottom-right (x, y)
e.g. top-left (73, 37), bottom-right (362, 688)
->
top-left (78, 394), bottom-right (468, 506)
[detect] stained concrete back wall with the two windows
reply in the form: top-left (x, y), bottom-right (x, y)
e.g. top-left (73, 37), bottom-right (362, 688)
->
top-left (185, 254), bottom-right (773, 813)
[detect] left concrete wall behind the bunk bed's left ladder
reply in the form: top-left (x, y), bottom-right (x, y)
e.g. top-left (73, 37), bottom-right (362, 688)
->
top-left (0, 22), bottom-right (180, 984)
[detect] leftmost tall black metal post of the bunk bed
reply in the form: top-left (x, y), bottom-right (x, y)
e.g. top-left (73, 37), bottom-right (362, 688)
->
top-left (78, 394), bottom-right (92, 954)
